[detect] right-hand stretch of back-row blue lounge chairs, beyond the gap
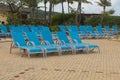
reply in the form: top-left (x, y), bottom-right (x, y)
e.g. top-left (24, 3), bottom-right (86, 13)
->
top-left (60, 25), bottom-right (119, 38)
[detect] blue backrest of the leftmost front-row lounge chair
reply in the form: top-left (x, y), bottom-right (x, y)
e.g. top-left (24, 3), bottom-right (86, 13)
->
top-left (11, 32), bottom-right (27, 47)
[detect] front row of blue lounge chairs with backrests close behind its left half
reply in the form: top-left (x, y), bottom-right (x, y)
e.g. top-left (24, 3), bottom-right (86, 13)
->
top-left (10, 26), bottom-right (100, 57)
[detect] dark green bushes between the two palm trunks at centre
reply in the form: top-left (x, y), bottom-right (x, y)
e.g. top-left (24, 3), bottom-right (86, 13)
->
top-left (52, 14), bottom-right (75, 25)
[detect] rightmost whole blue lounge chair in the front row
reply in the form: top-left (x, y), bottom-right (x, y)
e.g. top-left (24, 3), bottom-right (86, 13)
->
top-left (69, 32), bottom-right (100, 53)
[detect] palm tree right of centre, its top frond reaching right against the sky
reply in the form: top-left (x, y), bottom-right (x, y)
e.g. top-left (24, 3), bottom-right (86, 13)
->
top-left (75, 0), bottom-right (92, 25)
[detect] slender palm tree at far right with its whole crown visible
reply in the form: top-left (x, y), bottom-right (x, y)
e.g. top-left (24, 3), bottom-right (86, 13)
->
top-left (97, 0), bottom-right (111, 25)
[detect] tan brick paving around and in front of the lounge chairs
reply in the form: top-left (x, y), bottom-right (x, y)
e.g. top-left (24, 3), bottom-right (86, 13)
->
top-left (0, 39), bottom-right (120, 80)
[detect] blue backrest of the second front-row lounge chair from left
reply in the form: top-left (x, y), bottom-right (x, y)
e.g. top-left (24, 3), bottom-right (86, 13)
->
top-left (26, 32), bottom-right (41, 46)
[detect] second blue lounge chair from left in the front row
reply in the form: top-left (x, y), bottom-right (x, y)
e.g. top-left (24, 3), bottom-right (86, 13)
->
top-left (27, 32), bottom-right (61, 56)
